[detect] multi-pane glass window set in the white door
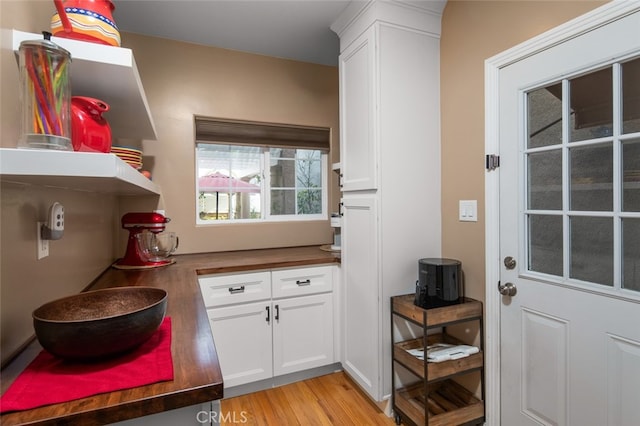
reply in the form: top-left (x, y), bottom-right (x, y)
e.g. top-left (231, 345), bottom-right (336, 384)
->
top-left (523, 58), bottom-right (640, 292)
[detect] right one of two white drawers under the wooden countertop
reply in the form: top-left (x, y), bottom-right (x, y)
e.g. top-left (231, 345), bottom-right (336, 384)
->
top-left (271, 266), bottom-right (333, 298)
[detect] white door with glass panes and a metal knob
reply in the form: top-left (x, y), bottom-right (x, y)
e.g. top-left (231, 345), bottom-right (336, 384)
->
top-left (497, 6), bottom-right (640, 426)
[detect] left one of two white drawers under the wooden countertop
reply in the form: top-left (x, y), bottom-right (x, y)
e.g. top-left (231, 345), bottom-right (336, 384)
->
top-left (198, 271), bottom-right (271, 307)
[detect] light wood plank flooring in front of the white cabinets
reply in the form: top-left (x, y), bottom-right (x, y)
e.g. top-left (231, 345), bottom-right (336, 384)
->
top-left (220, 372), bottom-right (395, 426)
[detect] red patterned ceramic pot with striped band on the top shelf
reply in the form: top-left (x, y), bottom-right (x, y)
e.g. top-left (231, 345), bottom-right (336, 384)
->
top-left (51, 0), bottom-right (120, 46)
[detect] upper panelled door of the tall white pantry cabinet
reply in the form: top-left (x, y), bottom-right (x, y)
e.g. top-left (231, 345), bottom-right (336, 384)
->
top-left (339, 28), bottom-right (377, 191)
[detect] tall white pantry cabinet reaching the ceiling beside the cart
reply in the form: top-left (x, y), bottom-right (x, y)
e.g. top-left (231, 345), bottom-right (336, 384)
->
top-left (331, 0), bottom-right (444, 401)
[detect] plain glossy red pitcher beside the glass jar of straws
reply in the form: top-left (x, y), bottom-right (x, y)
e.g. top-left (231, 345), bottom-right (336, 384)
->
top-left (71, 96), bottom-right (111, 152)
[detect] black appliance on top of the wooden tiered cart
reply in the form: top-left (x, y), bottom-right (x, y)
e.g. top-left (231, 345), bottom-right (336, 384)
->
top-left (414, 258), bottom-right (464, 309)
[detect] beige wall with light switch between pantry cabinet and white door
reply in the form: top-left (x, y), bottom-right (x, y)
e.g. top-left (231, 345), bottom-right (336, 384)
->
top-left (440, 0), bottom-right (606, 306)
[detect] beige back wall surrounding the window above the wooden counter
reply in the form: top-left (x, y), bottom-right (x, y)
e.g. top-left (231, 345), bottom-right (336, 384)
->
top-left (122, 34), bottom-right (339, 253)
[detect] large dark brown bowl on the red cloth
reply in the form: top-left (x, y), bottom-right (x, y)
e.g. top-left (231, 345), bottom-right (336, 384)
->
top-left (33, 287), bottom-right (167, 360)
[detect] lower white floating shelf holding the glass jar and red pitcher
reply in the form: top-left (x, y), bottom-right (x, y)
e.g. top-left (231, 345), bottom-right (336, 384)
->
top-left (0, 148), bottom-right (160, 195)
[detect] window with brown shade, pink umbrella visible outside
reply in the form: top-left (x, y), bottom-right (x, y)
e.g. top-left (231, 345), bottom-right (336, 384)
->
top-left (195, 117), bottom-right (330, 224)
